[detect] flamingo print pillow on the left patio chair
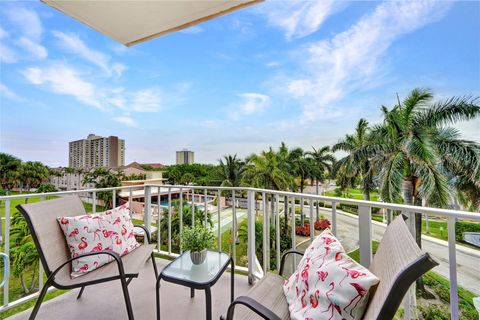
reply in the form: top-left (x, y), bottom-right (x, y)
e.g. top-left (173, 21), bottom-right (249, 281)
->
top-left (57, 205), bottom-right (140, 278)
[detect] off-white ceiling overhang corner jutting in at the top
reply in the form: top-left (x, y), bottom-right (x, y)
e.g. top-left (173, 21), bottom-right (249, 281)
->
top-left (42, 0), bottom-right (263, 46)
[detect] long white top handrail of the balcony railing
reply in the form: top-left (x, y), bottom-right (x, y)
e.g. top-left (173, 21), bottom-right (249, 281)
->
top-left (0, 184), bottom-right (480, 221)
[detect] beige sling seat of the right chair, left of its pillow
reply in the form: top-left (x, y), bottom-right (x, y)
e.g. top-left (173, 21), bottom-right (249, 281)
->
top-left (234, 273), bottom-right (290, 320)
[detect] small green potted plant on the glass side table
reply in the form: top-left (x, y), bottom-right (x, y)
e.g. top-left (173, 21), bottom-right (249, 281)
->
top-left (182, 225), bottom-right (215, 264)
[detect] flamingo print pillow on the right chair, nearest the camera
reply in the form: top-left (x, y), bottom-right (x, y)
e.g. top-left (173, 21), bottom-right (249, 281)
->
top-left (283, 229), bottom-right (379, 320)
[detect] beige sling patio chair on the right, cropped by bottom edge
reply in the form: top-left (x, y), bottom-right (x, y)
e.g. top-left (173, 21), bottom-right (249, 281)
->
top-left (227, 217), bottom-right (438, 320)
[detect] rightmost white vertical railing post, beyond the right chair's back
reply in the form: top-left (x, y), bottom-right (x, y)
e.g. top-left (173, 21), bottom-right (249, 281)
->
top-left (447, 217), bottom-right (458, 320)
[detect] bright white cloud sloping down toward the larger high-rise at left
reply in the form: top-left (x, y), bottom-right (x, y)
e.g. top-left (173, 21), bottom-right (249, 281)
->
top-left (22, 63), bottom-right (104, 109)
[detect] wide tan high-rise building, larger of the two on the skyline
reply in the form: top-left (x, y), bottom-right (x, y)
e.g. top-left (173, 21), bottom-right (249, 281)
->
top-left (68, 134), bottom-right (125, 168)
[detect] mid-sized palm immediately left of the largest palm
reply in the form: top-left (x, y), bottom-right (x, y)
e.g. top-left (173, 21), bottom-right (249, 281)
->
top-left (332, 118), bottom-right (374, 200)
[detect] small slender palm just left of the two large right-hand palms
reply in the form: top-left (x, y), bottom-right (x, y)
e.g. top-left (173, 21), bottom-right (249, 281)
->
top-left (306, 146), bottom-right (335, 220)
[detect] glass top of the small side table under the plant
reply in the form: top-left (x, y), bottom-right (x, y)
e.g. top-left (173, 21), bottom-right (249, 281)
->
top-left (162, 251), bottom-right (230, 283)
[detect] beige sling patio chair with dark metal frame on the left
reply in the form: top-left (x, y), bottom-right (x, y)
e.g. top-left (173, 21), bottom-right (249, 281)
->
top-left (17, 196), bottom-right (158, 320)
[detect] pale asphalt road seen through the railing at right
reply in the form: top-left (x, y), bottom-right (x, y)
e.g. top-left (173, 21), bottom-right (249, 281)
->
top-left (312, 208), bottom-right (480, 296)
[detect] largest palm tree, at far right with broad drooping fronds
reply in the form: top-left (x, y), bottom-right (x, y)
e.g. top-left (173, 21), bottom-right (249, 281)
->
top-left (370, 89), bottom-right (480, 246)
